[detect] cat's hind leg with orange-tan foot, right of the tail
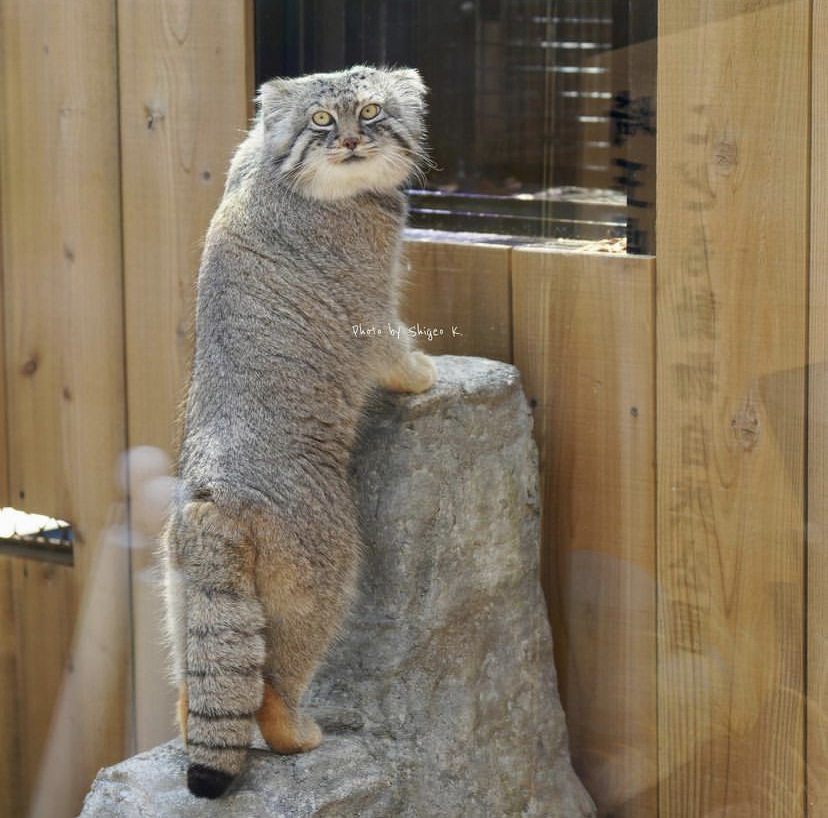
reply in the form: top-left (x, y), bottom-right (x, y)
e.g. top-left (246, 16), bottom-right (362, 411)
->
top-left (251, 501), bottom-right (360, 753)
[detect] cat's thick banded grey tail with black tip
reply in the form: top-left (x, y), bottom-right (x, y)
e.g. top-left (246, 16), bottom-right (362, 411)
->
top-left (178, 502), bottom-right (265, 798)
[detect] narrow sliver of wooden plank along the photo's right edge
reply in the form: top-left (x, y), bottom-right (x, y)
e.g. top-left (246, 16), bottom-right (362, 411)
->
top-left (807, 2), bottom-right (828, 818)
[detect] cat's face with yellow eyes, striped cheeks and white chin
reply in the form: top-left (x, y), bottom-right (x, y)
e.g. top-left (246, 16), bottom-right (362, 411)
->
top-left (259, 66), bottom-right (426, 200)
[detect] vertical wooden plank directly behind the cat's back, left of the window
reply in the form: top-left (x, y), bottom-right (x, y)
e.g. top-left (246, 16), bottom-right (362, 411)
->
top-left (118, 0), bottom-right (252, 748)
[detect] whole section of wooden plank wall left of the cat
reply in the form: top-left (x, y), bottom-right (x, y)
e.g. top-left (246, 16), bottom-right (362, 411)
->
top-left (0, 0), bottom-right (250, 818)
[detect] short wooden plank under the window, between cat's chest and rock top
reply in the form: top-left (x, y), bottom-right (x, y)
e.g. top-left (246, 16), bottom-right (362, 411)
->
top-left (400, 241), bottom-right (512, 363)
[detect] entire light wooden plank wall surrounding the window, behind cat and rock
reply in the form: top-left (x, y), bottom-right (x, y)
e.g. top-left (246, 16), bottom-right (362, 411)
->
top-left (0, 0), bottom-right (828, 818)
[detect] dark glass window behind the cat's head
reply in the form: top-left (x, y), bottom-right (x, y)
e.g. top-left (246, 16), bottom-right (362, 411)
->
top-left (256, 0), bottom-right (656, 252)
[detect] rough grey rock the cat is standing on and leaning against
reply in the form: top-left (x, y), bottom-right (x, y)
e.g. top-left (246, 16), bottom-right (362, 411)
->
top-left (81, 356), bottom-right (594, 818)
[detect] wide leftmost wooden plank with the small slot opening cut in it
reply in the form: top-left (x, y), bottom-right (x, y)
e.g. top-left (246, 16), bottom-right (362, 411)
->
top-left (0, 0), bottom-right (130, 818)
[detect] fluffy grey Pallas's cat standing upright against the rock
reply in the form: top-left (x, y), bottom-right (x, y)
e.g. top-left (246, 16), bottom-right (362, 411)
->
top-left (162, 66), bottom-right (435, 798)
